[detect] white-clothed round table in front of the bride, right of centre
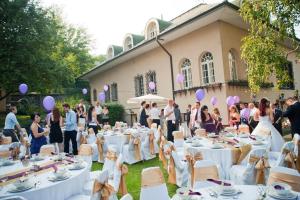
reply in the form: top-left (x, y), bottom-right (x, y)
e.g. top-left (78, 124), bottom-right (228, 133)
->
top-left (183, 137), bottom-right (268, 179)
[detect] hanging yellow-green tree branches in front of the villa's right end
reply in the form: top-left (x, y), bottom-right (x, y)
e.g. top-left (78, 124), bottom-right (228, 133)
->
top-left (240, 0), bottom-right (300, 93)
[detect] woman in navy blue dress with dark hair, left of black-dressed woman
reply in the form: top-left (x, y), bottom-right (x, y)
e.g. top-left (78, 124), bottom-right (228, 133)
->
top-left (30, 113), bottom-right (49, 154)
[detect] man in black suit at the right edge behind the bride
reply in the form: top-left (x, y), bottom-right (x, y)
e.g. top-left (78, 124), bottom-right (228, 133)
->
top-left (282, 97), bottom-right (300, 137)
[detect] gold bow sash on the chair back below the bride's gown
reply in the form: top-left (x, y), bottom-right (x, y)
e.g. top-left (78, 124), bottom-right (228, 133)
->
top-left (249, 155), bottom-right (270, 184)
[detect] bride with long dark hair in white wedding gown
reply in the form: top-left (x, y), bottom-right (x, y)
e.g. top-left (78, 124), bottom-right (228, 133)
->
top-left (252, 98), bottom-right (284, 151)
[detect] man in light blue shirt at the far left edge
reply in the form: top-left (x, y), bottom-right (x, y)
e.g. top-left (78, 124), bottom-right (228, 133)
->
top-left (3, 105), bottom-right (23, 142)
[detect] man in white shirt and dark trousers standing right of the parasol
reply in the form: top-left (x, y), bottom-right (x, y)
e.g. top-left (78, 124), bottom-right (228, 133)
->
top-left (164, 99), bottom-right (176, 142)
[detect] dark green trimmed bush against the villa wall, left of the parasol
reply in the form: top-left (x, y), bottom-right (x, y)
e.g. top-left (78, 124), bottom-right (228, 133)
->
top-left (105, 103), bottom-right (125, 125)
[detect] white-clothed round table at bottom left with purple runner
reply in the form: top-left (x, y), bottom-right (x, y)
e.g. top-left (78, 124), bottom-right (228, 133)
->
top-left (0, 159), bottom-right (89, 200)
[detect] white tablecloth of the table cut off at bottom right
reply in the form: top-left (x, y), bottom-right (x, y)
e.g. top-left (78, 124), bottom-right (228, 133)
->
top-left (172, 185), bottom-right (300, 200)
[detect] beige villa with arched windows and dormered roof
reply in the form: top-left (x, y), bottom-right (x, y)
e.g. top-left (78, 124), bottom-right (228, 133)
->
top-left (81, 1), bottom-right (300, 123)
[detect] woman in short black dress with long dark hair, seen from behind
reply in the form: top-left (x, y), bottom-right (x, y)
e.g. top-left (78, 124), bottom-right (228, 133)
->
top-left (48, 107), bottom-right (63, 153)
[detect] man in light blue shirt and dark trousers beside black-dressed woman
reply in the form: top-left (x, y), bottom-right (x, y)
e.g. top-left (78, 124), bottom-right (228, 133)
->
top-left (63, 103), bottom-right (78, 155)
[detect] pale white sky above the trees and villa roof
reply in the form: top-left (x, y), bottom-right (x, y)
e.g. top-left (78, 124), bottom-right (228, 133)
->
top-left (41, 0), bottom-right (222, 55)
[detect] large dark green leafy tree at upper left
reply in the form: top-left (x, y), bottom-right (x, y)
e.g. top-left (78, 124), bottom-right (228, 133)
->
top-left (0, 0), bottom-right (98, 100)
